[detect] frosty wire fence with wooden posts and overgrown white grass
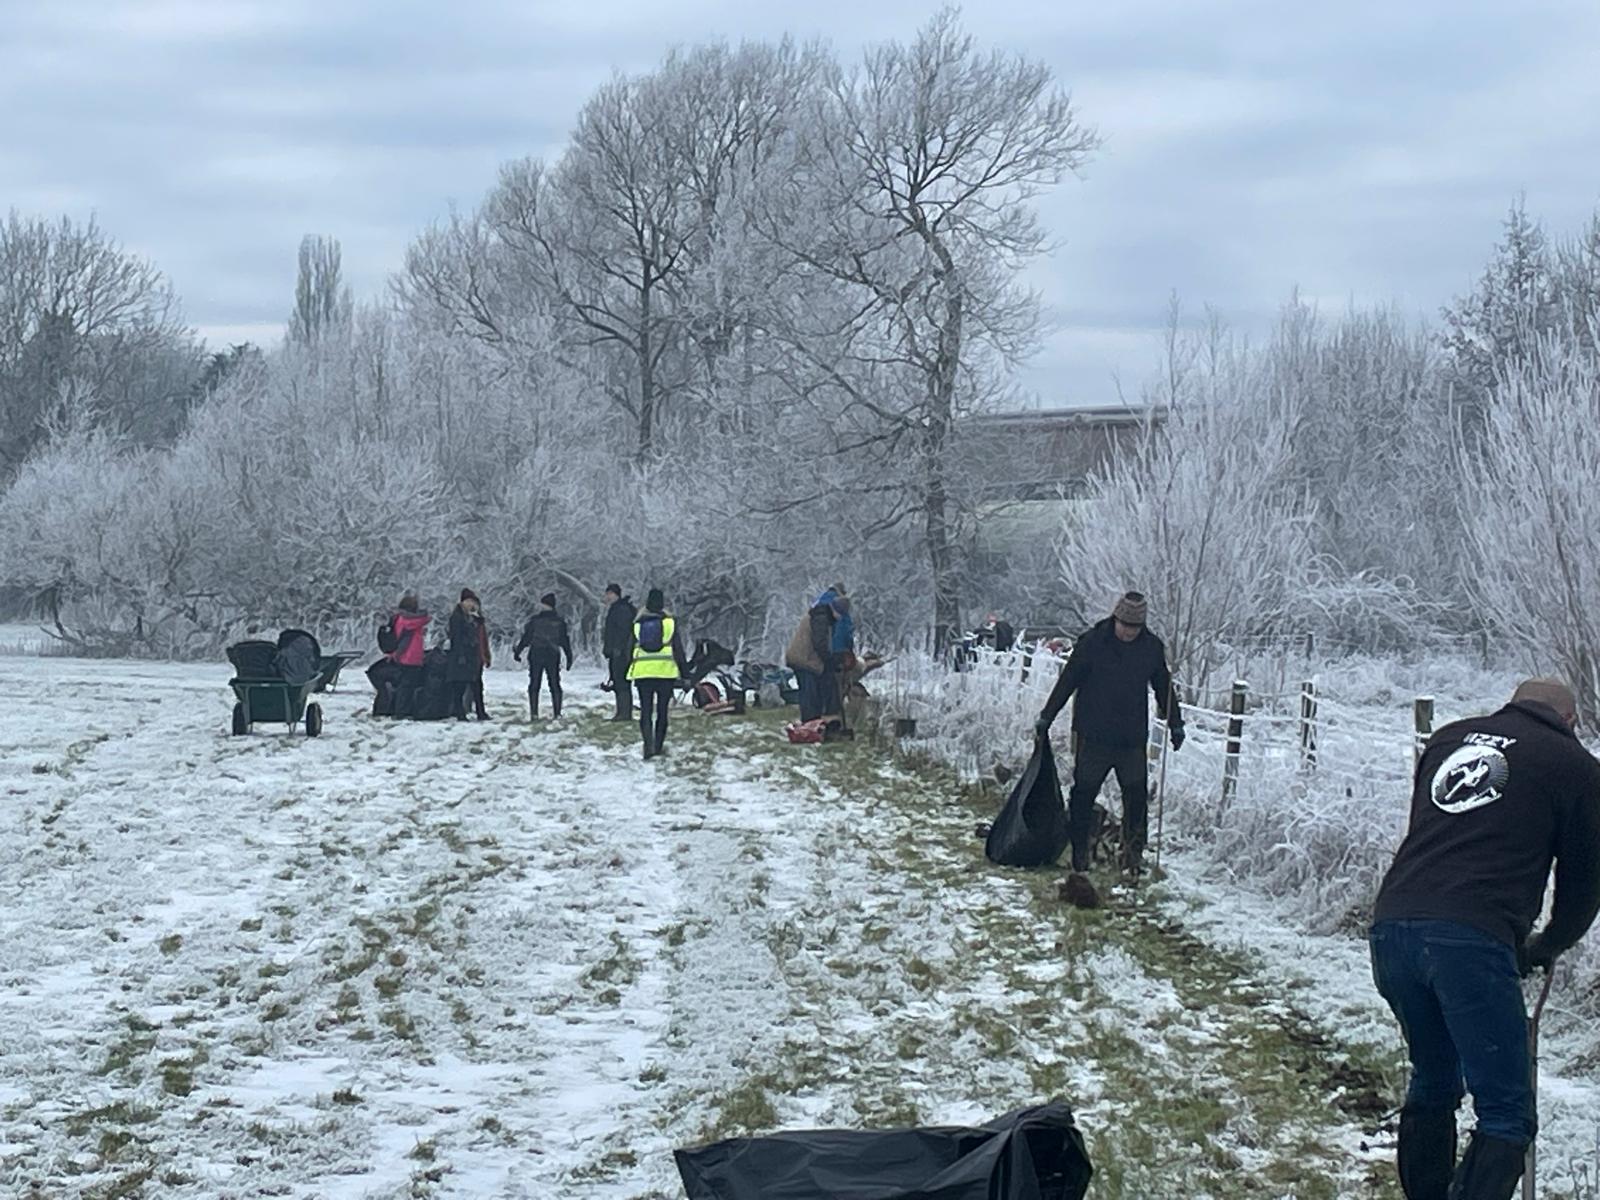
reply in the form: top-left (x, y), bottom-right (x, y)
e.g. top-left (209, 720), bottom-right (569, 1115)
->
top-left (885, 648), bottom-right (1461, 930)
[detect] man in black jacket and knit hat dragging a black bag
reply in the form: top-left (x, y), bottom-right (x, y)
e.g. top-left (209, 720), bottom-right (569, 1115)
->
top-left (1034, 592), bottom-right (1184, 872)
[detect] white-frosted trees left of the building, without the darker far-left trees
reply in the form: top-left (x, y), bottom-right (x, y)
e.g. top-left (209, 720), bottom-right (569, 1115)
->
top-left (0, 13), bottom-right (1096, 643)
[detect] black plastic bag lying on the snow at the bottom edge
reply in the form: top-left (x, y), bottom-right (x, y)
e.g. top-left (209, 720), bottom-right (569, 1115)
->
top-left (677, 1104), bottom-right (1094, 1200)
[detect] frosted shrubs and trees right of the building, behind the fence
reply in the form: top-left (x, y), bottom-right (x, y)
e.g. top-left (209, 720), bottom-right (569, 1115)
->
top-left (1058, 205), bottom-right (1600, 715)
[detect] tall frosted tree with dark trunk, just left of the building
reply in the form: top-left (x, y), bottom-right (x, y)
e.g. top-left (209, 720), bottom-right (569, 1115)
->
top-left (762, 10), bottom-right (1096, 643)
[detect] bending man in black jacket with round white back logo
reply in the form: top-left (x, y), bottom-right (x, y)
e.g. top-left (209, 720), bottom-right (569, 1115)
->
top-left (1370, 680), bottom-right (1600, 1200)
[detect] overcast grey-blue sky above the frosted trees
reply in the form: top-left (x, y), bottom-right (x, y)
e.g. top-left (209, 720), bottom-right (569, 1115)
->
top-left (0, 0), bottom-right (1600, 405)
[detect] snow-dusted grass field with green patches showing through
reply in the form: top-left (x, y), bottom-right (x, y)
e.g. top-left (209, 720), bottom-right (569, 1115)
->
top-left (0, 656), bottom-right (1594, 1200)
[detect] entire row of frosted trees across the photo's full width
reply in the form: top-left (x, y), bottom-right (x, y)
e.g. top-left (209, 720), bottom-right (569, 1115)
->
top-left (0, 7), bottom-right (1600, 704)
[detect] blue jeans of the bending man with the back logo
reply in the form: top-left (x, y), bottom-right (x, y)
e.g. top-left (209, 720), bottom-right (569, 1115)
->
top-left (1368, 920), bottom-right (1538, 1142)
